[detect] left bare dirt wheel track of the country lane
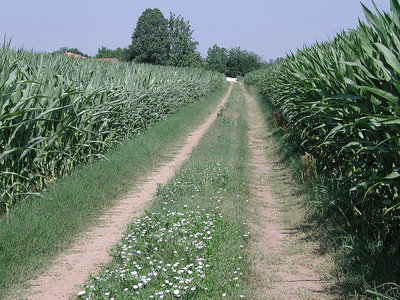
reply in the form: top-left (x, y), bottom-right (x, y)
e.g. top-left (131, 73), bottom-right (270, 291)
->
top-left (26, 86), bottom-right (232, 300)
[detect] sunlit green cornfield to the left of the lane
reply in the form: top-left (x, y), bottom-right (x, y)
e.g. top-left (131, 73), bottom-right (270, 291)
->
top-left (0, 43), bottom-right (224, 212)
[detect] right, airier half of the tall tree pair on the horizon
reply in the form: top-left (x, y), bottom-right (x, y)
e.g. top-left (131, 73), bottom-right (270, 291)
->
top-left (168, 13), bottom-right (201, 67)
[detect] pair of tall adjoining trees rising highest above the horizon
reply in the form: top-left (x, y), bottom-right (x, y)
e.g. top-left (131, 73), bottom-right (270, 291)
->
top-left (130, 8), bottom-right (203, 67)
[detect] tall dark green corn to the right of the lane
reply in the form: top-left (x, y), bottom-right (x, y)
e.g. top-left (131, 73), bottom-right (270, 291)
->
top-left (245, 0), bottom-right (400, 296)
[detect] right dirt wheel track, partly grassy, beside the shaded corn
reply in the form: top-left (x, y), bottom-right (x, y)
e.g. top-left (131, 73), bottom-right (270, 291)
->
top-left (242, 85), bottom-right (326, 299)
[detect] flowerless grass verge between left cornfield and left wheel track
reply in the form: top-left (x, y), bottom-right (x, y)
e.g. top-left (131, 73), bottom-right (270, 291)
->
top-left (0, 84), bottom-right (226, 297)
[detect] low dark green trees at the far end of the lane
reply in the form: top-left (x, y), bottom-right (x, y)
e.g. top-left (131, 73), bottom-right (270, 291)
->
top-left (206, 45), bottom-right (263, 77)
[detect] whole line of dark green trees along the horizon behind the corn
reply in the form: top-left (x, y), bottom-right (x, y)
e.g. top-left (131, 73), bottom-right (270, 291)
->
top-left (58, 8), bottom-right (266, 77)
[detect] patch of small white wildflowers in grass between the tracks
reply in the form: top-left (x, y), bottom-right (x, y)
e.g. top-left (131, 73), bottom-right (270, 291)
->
top-left (78, 164), bottom-right (248, 299)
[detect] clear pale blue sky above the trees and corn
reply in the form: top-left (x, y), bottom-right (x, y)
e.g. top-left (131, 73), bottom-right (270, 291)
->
top-left (0, 0), bottom-right (390, 60)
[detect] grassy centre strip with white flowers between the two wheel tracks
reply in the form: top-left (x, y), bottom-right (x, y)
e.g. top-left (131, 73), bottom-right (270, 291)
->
top-left (79, 83), bottom-right (249, 299)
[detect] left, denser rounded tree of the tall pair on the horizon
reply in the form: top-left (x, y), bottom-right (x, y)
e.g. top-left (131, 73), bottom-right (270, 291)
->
top-left (130, 8), bottom-right (169, 65)
